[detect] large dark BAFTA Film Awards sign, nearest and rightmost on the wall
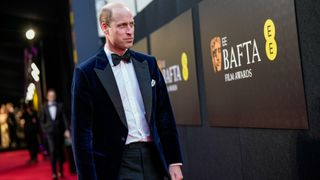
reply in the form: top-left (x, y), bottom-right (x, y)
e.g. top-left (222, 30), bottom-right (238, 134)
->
top-left (200, 0), bottom-right (308, 129)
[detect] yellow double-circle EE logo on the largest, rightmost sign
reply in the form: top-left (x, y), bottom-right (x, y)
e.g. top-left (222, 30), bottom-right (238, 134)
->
top-left (263, 19), bottom-right (278, 61)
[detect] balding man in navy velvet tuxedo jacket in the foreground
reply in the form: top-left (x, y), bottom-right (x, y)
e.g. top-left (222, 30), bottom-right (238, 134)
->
top-left (71, 3), bottom-right (183, 180)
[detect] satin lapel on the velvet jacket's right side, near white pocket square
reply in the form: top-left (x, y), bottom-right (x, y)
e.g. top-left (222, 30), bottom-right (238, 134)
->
top-left (132, 58), bottom-right (152, 122)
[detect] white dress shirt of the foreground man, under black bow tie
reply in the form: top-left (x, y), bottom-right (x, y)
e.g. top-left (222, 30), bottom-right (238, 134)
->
top-left (104, 47), bottom-right (151, 144)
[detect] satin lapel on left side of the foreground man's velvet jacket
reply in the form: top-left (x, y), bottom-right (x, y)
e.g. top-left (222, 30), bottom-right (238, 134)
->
top-left (94, 54), bottom-right (128, 127)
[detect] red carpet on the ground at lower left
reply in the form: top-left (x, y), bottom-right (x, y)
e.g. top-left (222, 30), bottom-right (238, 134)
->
top-left (0, 150), bottom-right (77, 180)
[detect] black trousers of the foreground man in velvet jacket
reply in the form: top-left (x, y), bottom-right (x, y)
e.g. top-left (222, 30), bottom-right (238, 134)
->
top-left (118, 142), bottom-right (164, 180)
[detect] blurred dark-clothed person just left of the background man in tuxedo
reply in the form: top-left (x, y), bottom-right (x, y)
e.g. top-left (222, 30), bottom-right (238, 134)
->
top-left (21, 103), bottom-right (39, 164)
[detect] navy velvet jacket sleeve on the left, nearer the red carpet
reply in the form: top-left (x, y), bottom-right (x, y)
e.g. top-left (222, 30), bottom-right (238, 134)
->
top-left (71, 67), bottom-right (97, 180)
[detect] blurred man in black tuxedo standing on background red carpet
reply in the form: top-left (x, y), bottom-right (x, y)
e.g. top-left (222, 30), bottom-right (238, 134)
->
top-left (40, 89), bottom-right (70, 179)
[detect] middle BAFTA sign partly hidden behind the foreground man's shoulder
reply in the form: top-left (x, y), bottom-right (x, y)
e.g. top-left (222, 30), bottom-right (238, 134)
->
top-left (150, 10), bottom-right (201, 125)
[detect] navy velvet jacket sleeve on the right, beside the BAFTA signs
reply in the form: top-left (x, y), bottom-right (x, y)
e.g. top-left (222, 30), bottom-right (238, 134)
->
top-left (154, 57), bottom-right (182, 166)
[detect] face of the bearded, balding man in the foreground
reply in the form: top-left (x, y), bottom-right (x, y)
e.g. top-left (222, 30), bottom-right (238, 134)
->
top-left (106, 8), bottom-right (134, 51)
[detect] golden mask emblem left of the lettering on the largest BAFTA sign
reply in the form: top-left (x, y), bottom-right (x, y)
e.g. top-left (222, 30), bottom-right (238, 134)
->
top-left (211, 37), bottom-right (222, 72)
